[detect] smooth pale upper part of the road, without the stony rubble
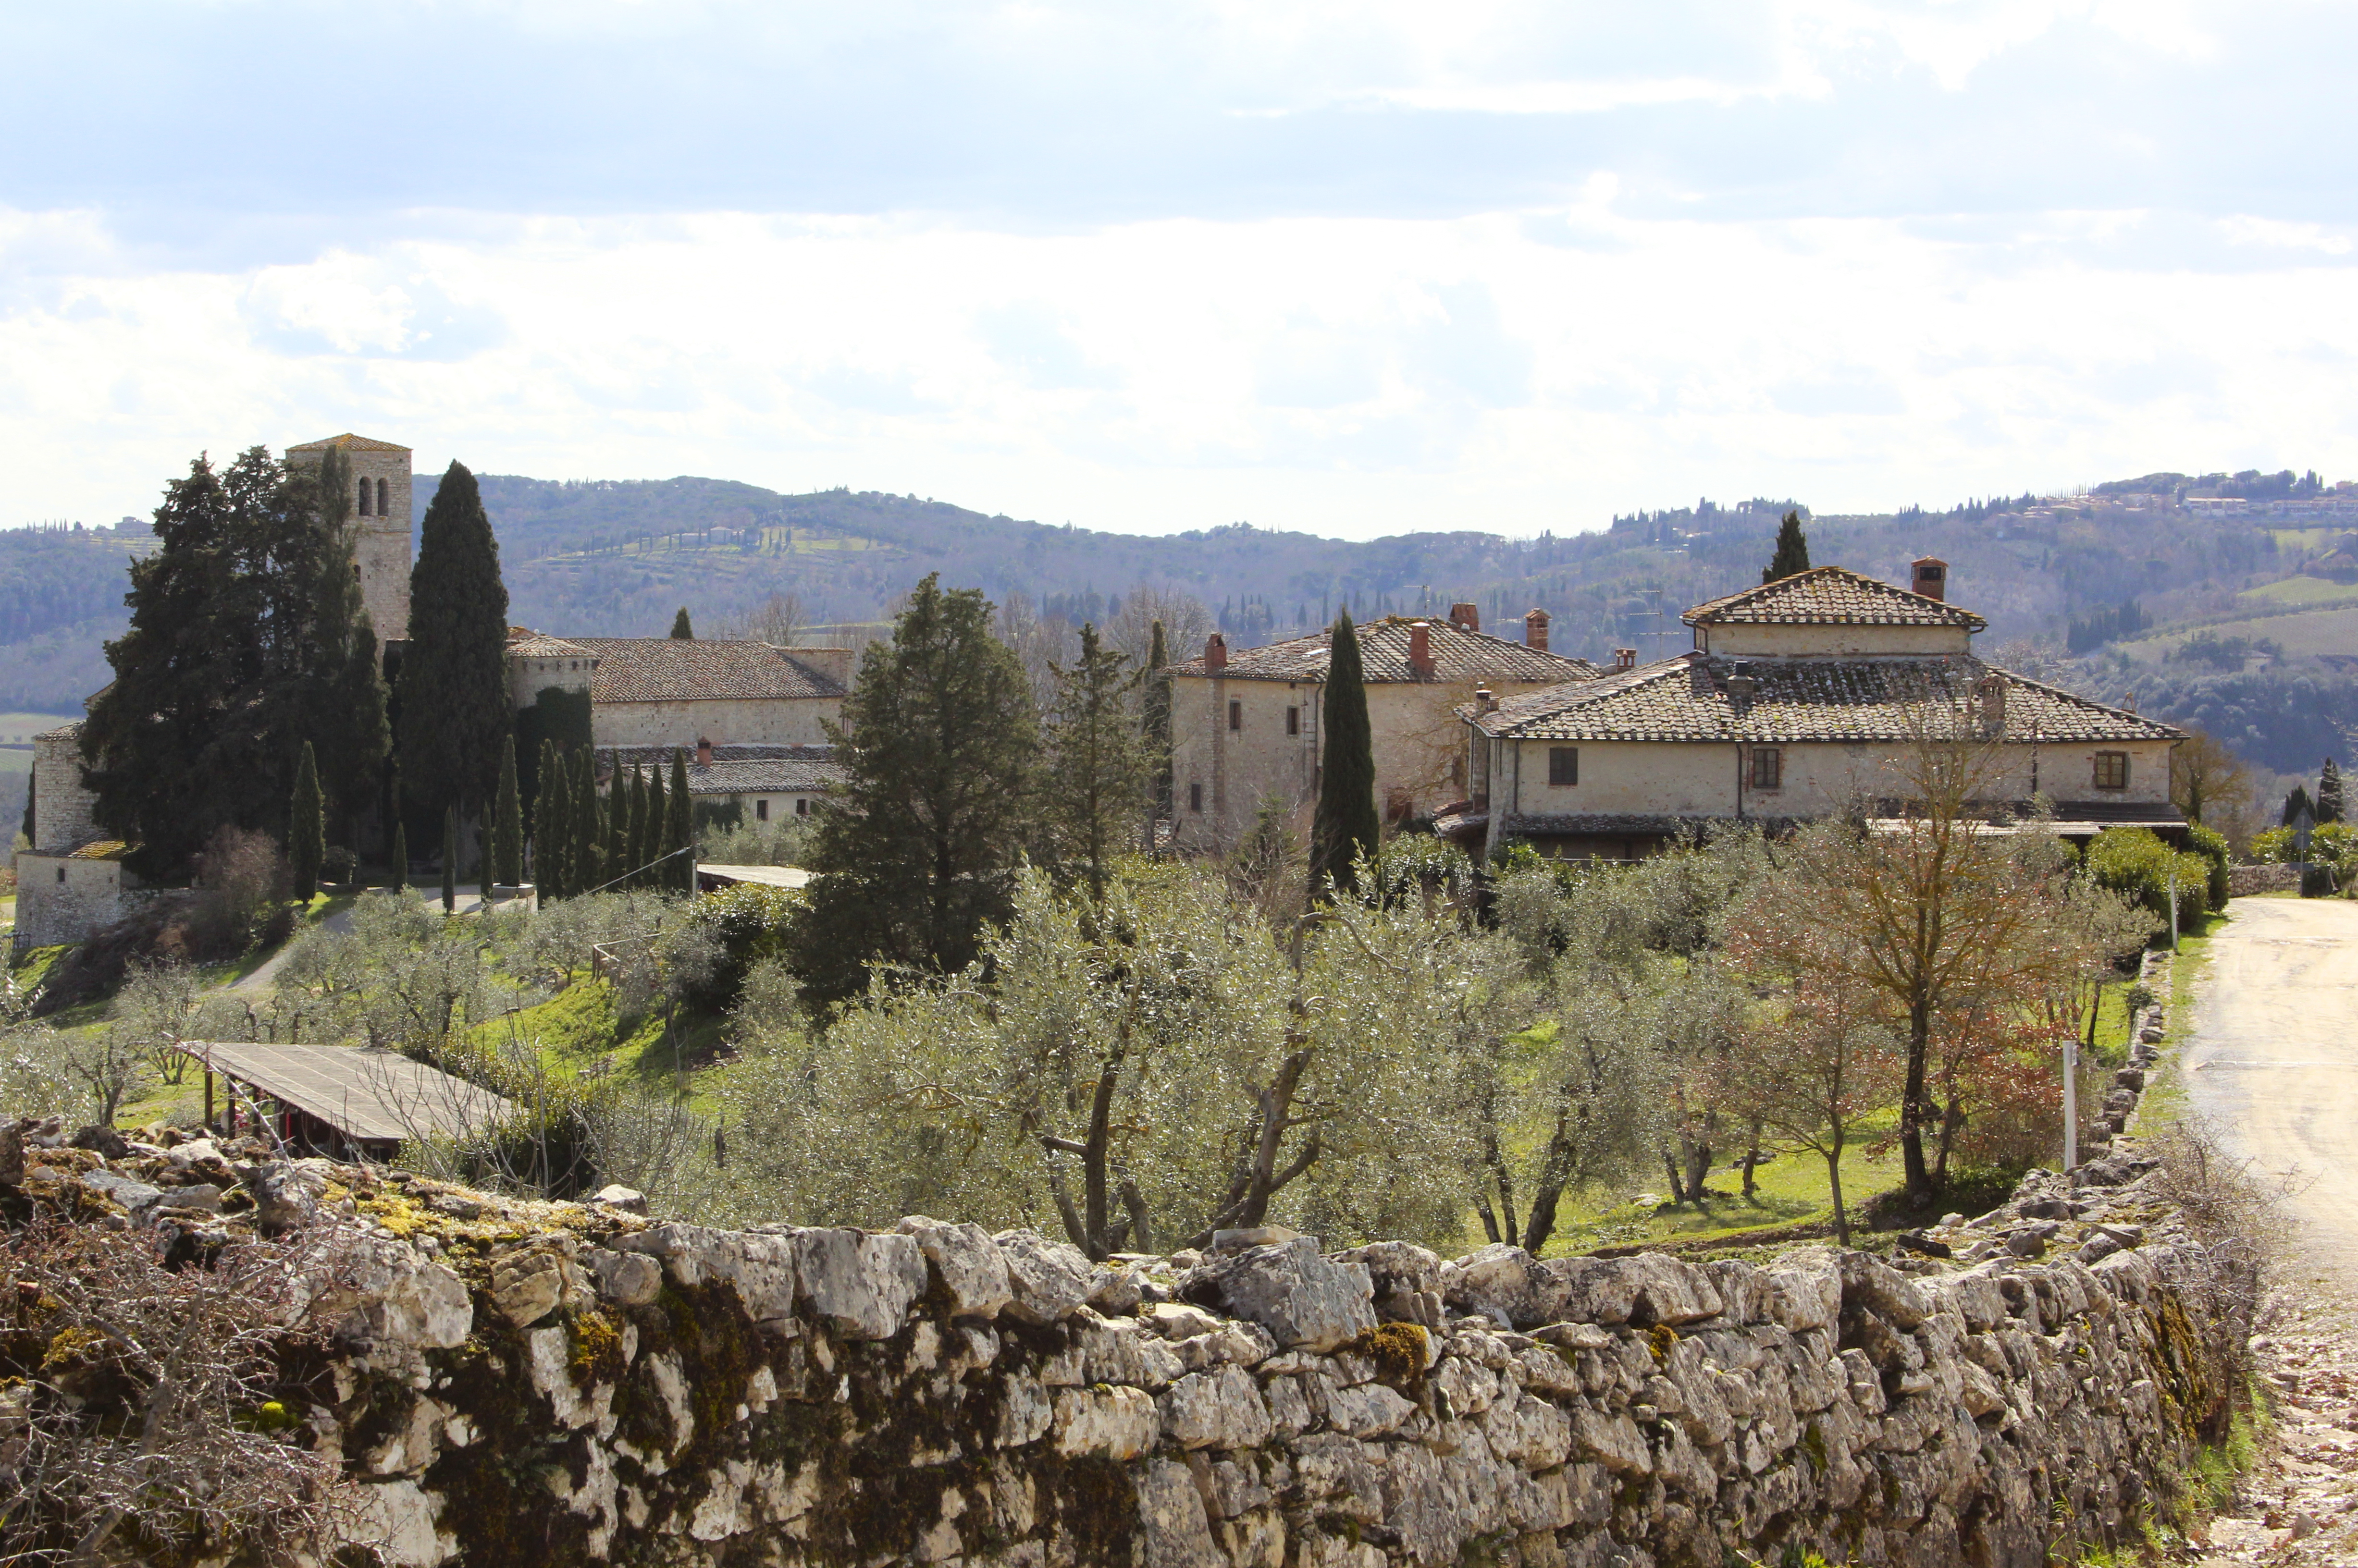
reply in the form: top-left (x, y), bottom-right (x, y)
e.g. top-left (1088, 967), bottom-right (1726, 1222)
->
top-left (2172, 898), bottom-right (2358, 1295)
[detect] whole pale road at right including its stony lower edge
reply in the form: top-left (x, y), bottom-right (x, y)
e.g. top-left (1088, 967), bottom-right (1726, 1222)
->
top-left (2172, 898), bottom-right (2358, 1568)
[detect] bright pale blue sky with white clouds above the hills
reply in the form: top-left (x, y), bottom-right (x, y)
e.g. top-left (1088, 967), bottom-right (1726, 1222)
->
top-left (0, 0), bottom-right (2358, 538)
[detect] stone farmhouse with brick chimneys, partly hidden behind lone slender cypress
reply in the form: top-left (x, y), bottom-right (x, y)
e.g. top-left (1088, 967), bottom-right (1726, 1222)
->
top-left (1167, 604), bottom-right (1596, 851)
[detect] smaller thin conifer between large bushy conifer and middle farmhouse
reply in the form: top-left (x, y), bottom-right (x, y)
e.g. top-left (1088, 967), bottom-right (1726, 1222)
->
top-left (1042, 623), bottom-right (1148, 901)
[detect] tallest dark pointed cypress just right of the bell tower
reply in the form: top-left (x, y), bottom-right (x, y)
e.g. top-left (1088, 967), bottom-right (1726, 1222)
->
top-left (401, 462), bottom-right (514, 811)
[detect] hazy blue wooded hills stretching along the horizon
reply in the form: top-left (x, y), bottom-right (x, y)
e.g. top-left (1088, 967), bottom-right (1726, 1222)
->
top-left (13, 455), bottom-right (2358, 769)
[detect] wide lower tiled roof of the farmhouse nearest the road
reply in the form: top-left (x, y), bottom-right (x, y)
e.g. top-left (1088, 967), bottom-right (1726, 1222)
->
top-left (1459, 653), bottom-right (2184, 743)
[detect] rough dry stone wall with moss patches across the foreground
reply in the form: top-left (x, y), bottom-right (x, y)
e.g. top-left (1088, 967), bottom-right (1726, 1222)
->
top-left (9, 1108), bottom-right (2240, 1568)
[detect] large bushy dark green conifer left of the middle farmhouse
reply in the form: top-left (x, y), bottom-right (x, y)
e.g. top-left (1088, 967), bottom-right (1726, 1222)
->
top-left (792, 573), bottom-right (1037, 1002)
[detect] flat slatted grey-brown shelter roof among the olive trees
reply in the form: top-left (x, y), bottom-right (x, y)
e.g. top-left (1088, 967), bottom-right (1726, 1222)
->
top-left (179, 1040), bottom-right (509, 1141)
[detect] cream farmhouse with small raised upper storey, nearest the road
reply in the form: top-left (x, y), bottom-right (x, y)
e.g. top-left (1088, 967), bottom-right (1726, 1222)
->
top-left (1436, 559), bottom-right (2186, 858)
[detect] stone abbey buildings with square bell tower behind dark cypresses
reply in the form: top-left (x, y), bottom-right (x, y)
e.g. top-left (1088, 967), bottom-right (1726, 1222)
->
top-left (16, 431), bottom-right (851, 950)
